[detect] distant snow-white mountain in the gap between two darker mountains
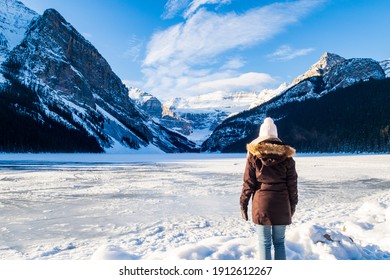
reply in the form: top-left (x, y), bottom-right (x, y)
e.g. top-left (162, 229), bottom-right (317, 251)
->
top-left (129, 84), bottom-right (287, 144)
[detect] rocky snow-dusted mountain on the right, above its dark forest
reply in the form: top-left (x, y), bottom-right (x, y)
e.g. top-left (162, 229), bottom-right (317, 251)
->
top-left (202, 53), bottom-right (388, 152)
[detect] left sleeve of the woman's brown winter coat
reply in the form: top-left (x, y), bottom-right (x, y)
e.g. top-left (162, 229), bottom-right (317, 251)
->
top-left (240, 153), bottom-right (257, 210)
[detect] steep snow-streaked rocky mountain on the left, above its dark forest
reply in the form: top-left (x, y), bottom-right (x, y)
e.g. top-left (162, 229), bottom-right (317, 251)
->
top-left (0, 1), bottom-right (195, 152)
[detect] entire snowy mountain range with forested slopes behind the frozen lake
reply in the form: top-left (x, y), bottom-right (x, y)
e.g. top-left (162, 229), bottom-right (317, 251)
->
top-left (0, 0), bottom-right (390, 153)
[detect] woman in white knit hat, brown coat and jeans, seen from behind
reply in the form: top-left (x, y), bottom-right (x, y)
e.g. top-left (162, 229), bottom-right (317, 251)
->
top-left (240, 118), bottom-right (298, 260)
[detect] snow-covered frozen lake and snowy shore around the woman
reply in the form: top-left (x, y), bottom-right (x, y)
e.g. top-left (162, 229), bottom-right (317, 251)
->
top-left (0, 154), bottom-right (390, 260)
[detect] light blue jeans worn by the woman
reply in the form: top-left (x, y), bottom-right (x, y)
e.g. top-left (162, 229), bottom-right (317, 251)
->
top-left (256, 225), bottom-right (286, 260)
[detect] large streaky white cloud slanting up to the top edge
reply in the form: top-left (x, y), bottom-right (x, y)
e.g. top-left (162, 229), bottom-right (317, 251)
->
top-left (144, 1), bottom-right (318, 66)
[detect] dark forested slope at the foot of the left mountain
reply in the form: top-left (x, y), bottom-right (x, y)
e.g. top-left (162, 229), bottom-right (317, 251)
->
top-left (0, 81), bottom-right (103, 152)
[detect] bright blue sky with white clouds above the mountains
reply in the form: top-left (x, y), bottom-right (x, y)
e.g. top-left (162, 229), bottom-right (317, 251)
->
top-left (21, 0), bottom-right (390, 100)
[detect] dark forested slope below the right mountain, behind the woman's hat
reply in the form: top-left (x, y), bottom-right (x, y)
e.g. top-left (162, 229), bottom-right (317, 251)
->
top-left (222, 79), bottom-right (390, 153)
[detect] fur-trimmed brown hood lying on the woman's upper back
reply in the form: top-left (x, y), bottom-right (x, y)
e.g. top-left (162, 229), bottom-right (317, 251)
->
top-left (246, 142), bottom-right (295, 165)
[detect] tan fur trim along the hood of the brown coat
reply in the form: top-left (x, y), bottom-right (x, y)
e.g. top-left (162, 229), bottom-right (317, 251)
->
top-left (246, 142), bottom-right (295, 158)
